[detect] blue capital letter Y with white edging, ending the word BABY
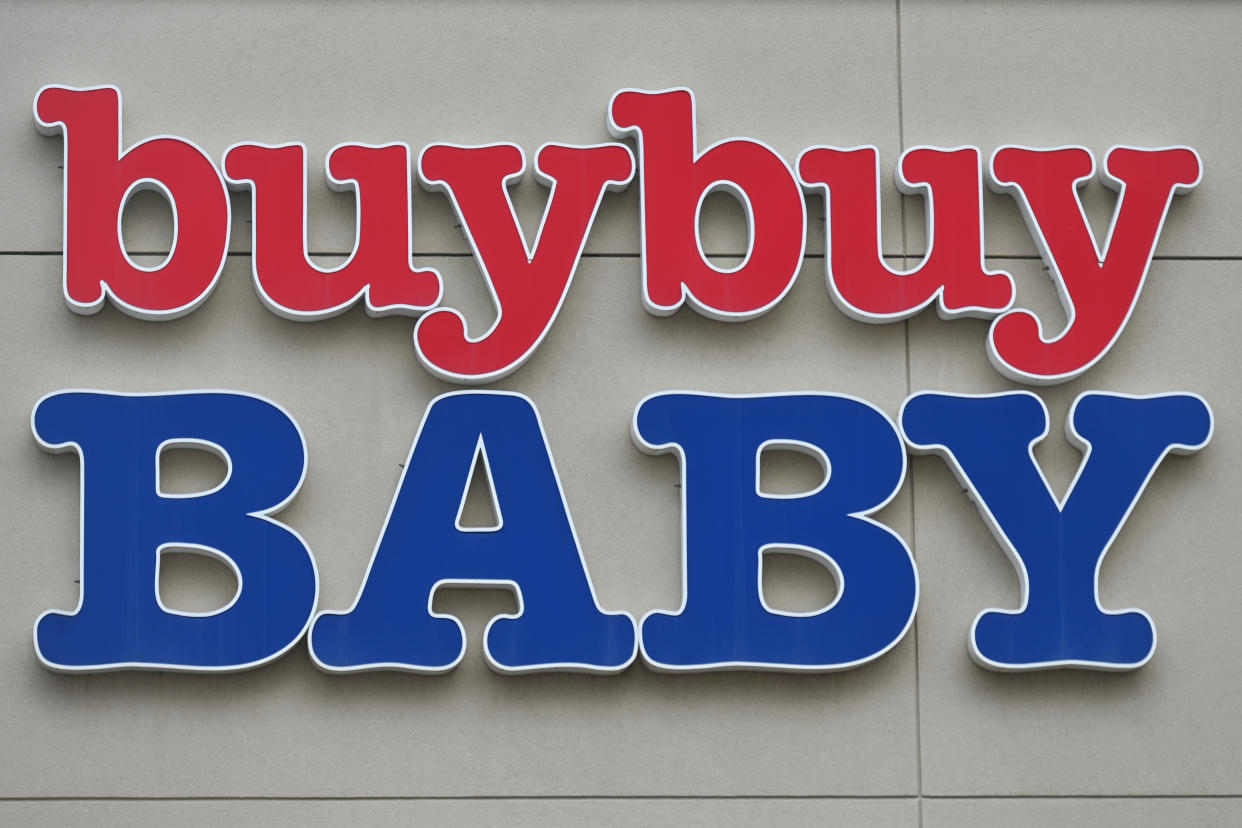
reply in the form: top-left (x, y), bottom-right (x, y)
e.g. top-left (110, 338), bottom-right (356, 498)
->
top-left (900, 391), bottom-right (1212, 670)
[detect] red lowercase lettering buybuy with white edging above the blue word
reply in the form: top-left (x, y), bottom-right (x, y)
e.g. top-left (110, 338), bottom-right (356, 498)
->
top-left (35, 86), bottom-right (1201, 384)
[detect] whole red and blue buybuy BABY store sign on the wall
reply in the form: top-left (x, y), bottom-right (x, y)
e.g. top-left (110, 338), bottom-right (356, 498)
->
top-left (32, 86), bottom-right (1212, 673)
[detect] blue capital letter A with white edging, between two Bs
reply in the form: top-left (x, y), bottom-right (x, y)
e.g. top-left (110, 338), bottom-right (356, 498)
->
top-left (311, 391), bottom-right (637, 673)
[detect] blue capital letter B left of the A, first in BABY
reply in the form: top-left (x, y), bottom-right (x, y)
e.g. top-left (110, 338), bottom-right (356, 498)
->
top-left (31, 391), bottom-right (319, 672)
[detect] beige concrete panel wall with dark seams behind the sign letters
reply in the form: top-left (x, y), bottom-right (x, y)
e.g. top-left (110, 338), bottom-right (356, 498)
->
top-left (0, 0), bottom-right (1242, 826)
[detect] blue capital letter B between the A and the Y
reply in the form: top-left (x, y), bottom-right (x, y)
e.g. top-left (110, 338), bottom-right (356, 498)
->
top-left (633, 394), bottom-right (918, 670)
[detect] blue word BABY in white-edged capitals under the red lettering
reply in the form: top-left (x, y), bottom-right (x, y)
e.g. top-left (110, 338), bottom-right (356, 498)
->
top-left (32, 391), bottom-right (1212, 673)
